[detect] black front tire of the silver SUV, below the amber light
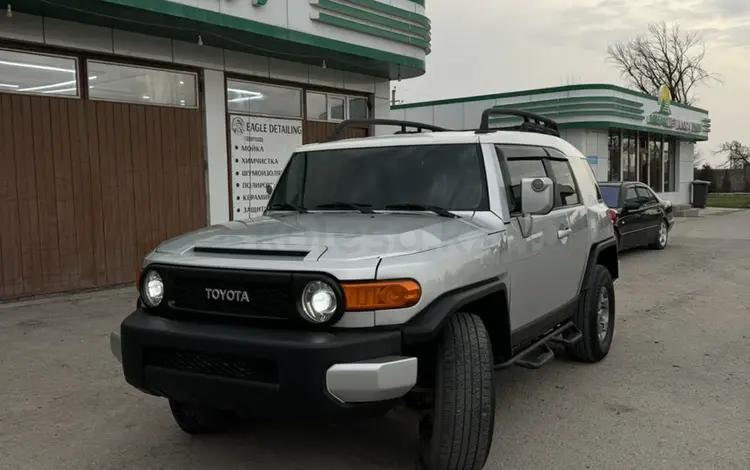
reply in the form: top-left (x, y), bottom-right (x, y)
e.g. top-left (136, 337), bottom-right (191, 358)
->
top-left (419, 313), bottom-right (495, 470)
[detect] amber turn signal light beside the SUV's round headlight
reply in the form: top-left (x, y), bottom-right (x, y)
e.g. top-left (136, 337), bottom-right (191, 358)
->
top-left (341, 279), bottom-right (422, 311)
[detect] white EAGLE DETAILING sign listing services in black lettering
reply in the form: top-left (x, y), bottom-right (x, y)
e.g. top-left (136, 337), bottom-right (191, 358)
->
top-left (229, 115), bottom-right (302, 219)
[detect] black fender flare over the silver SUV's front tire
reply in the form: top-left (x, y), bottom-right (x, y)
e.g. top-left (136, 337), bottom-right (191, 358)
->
top-left (401, 278), bottom-right (509, 346)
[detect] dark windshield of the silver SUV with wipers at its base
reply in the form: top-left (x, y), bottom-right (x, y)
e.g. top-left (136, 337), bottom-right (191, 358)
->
top-left (269, 144), bottom-right (488, 211)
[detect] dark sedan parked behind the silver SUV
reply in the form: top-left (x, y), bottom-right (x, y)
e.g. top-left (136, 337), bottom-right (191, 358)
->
top-left (599, 181), bottom-right (674, 250)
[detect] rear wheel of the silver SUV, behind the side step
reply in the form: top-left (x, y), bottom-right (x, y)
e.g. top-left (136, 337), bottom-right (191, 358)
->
top-left (567, 264), bottom-right (615, 362)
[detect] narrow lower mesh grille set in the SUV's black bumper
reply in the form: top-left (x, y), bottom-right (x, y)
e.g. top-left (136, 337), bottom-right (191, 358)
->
top-left (144, 348), bottom-right (278, 384)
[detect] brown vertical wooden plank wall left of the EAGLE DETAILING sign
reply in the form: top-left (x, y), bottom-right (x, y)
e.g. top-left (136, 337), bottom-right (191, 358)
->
top-left (0, 94), bottom-right (206, 299)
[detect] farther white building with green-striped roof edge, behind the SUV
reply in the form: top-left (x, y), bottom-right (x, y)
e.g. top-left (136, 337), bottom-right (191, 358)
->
top-left (391, 84), bottom-right (711, 204)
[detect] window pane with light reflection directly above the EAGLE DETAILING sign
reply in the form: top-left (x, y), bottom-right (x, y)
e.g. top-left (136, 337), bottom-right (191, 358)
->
top-left (227, 80), bottom-right (302, 118)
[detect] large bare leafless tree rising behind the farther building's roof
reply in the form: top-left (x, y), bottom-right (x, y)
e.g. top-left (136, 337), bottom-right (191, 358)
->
top-left (607, 21), bottom-right (720, 104)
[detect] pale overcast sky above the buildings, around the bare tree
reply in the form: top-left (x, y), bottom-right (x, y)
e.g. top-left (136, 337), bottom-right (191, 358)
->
top-left (392, 0), bottom-right (750, 166)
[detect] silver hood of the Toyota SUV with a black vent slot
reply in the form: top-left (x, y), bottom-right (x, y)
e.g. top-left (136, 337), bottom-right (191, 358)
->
top-left (156, 212), bottom-right (487, 261)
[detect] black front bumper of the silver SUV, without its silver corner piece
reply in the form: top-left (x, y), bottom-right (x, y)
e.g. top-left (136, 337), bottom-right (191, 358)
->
top-left (120, 309), bottom-right (402, 417)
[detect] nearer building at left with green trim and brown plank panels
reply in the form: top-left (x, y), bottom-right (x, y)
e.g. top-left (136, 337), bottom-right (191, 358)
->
top-left (0, 0), bottom-right (430, 300)
